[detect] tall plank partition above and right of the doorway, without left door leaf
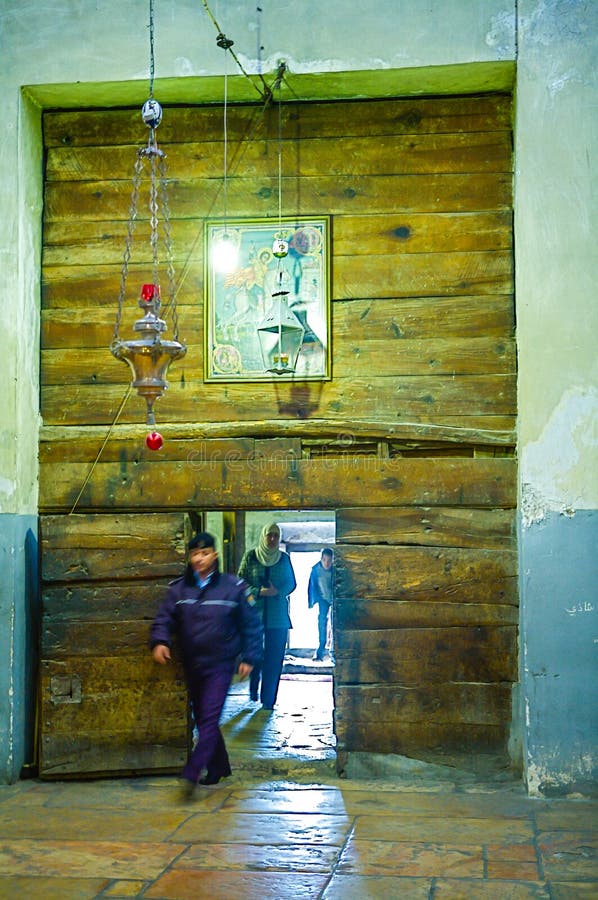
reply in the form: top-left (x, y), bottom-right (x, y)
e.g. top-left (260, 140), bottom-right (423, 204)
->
top-left (40, 95), bottom-right (517, 772)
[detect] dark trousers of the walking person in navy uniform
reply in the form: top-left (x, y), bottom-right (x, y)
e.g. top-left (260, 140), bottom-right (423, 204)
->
top-left (183, 662), bottom-right (235, 781)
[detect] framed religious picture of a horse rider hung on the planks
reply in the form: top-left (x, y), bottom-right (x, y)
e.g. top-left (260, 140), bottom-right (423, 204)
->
top-left (204, 216), bottom-right (331, 381)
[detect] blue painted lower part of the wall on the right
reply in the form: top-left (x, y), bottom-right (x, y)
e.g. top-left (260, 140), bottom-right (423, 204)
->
top-left (519, 510), bottom-right (598, 796)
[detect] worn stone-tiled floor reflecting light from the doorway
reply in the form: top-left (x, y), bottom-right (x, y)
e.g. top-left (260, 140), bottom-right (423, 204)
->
top-left (0, 667), bottom-right (598, 900)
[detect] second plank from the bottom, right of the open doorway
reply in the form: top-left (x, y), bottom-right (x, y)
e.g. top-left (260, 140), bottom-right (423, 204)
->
top-left (335, 683), bottom-right (512, 734)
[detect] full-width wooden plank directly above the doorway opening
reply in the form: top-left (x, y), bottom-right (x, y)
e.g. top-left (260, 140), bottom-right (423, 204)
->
top-left (39, 458), bottom-right (517, 512)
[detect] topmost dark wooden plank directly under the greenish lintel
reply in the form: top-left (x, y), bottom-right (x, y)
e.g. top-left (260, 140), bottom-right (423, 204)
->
top-left (43, 94), bottom-right (512, 149)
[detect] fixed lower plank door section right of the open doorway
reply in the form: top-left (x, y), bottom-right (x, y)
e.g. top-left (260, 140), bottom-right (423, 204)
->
top-left (335, 495), bottom-right (518, 769)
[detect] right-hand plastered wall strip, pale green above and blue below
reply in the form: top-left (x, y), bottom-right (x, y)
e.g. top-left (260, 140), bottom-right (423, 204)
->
top-left (515, 0), bottom-right (598, 794)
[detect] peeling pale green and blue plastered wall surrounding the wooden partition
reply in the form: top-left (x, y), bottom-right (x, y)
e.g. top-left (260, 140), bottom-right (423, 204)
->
top-left (0, 0), bottom-right (598, 792)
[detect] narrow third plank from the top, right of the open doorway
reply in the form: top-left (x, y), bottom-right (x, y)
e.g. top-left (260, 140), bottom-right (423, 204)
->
top-left (335, 600), bottom-right (519, 631)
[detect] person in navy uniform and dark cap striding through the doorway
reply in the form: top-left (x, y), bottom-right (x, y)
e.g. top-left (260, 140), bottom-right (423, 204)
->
top-left (150, 531), bottom-right (263, 797)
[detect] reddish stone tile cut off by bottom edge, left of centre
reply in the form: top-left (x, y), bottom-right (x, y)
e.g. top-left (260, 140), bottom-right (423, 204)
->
top-left (144, 869), bottom-right (326, 900)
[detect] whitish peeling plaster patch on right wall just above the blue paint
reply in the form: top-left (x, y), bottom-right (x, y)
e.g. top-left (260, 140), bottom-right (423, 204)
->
top-left (521, 387), bottom-right (598, 526)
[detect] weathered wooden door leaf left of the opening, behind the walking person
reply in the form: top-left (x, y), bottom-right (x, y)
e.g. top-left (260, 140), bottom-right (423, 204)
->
top-left (39, 512), bottom-right (189, 778)
